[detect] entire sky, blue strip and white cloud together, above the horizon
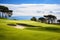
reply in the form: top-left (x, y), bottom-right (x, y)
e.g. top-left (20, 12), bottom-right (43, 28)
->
top-left (0, 0), bottom-right (60, 19)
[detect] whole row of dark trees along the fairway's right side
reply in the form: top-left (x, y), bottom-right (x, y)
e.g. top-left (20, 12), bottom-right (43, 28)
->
top-left (31, 15), bottom-right (60, 24)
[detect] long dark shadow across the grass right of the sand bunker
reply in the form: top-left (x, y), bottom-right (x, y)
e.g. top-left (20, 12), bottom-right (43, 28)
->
top-left (26, 27), bottom-right (60, 33)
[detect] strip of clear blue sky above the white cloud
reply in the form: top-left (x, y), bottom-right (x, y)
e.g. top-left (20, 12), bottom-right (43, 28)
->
top-left (0, 0), bottom-right (60, 4)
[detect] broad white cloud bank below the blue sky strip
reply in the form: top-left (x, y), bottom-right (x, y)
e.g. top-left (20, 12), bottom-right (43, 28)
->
top-left (1, 4), bottom-right (60, 18)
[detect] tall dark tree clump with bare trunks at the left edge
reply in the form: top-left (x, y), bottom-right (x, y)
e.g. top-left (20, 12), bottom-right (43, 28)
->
top-left (0, 5), bottom-right (12, 18)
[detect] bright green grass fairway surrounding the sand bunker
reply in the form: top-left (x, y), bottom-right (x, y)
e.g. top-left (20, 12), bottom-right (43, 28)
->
top-left (0, 19), bottom-right (60, 40)
